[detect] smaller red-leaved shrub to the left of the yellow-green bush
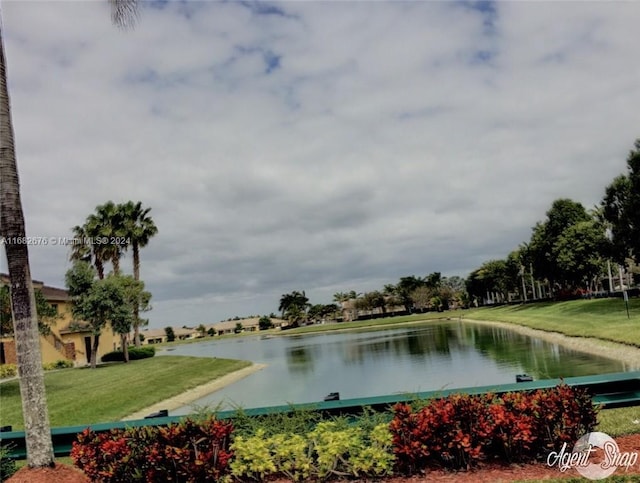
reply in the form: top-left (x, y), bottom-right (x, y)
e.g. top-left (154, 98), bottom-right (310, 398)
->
top-left (71, 418), bottom-right (233, 483)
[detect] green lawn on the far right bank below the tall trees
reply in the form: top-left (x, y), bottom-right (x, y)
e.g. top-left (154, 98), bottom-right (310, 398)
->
top-left (460, 298), bottom-right (640, 347)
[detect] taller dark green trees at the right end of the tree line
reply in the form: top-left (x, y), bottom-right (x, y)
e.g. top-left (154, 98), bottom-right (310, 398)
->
top-left (466, 139), bottom-right (640, 303)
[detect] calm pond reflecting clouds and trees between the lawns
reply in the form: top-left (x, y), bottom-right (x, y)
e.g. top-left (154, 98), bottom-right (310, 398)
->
top-left (159, 321), bottom-right (627, 415)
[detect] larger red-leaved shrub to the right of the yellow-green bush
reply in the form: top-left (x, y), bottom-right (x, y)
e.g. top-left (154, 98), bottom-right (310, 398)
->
top-left (390, 384), bottom-right (597, 473)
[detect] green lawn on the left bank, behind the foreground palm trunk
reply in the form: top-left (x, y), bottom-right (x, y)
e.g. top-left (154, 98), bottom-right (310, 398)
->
top-left (0, 356), bottom-right (251, 430)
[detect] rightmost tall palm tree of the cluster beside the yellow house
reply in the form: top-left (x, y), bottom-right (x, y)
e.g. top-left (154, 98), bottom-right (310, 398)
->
top-left (120, 201), bottom-right (158, 347)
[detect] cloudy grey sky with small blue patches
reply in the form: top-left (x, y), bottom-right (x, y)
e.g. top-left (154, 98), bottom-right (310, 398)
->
top-left (0, 0), bottom-right (640, 327)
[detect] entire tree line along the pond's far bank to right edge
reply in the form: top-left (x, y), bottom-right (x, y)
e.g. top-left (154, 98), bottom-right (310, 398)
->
top-left (278, 139), bottom-right (640, 320)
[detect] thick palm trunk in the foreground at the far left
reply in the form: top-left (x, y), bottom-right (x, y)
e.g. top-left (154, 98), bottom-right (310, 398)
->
top-left (0, 22), bottom-right (54, 467)
